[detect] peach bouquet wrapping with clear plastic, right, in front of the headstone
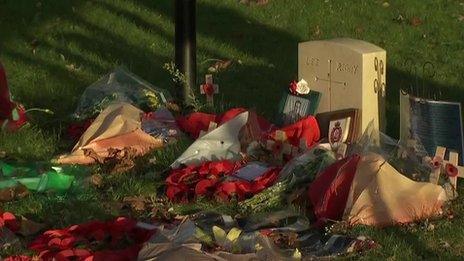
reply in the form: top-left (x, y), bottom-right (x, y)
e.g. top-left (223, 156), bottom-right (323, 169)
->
top-left (342, 122), bottom-right (448, 227)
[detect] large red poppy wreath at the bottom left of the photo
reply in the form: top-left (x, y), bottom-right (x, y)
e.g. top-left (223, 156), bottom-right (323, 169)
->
top-left (7, 217), bottom-right (154, 261)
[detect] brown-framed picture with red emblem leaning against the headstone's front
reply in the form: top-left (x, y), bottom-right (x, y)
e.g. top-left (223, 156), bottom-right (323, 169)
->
top-left (316, 109), bottom-right (359, 144)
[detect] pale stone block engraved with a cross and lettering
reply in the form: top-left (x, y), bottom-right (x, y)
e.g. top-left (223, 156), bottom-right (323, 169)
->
top-left (298, 38), bottom-right (387, 134)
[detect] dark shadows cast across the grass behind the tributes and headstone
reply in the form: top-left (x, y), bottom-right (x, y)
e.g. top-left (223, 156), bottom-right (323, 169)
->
top-left (0, 0), bottom-right (464, 130)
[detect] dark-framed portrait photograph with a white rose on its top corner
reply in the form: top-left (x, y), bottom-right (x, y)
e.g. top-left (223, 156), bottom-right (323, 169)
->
top-left (277, 91), bottom-right (321, 126)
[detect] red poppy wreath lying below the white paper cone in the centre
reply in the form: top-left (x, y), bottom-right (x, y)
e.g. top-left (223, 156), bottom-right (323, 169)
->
top-left (166, 160), bottom-right (280, 202)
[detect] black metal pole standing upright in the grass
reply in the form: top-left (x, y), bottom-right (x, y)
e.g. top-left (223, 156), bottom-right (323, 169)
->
top-left (175, 0), bottom-right (197, 105)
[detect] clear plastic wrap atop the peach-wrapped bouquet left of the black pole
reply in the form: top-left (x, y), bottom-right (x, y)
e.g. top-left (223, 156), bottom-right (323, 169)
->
top-left (73, 67), bottom-right (171, 120)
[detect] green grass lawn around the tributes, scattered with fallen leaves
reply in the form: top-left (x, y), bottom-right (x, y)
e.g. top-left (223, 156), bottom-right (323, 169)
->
top-left (0, 0), bottom-right (464, 260)
